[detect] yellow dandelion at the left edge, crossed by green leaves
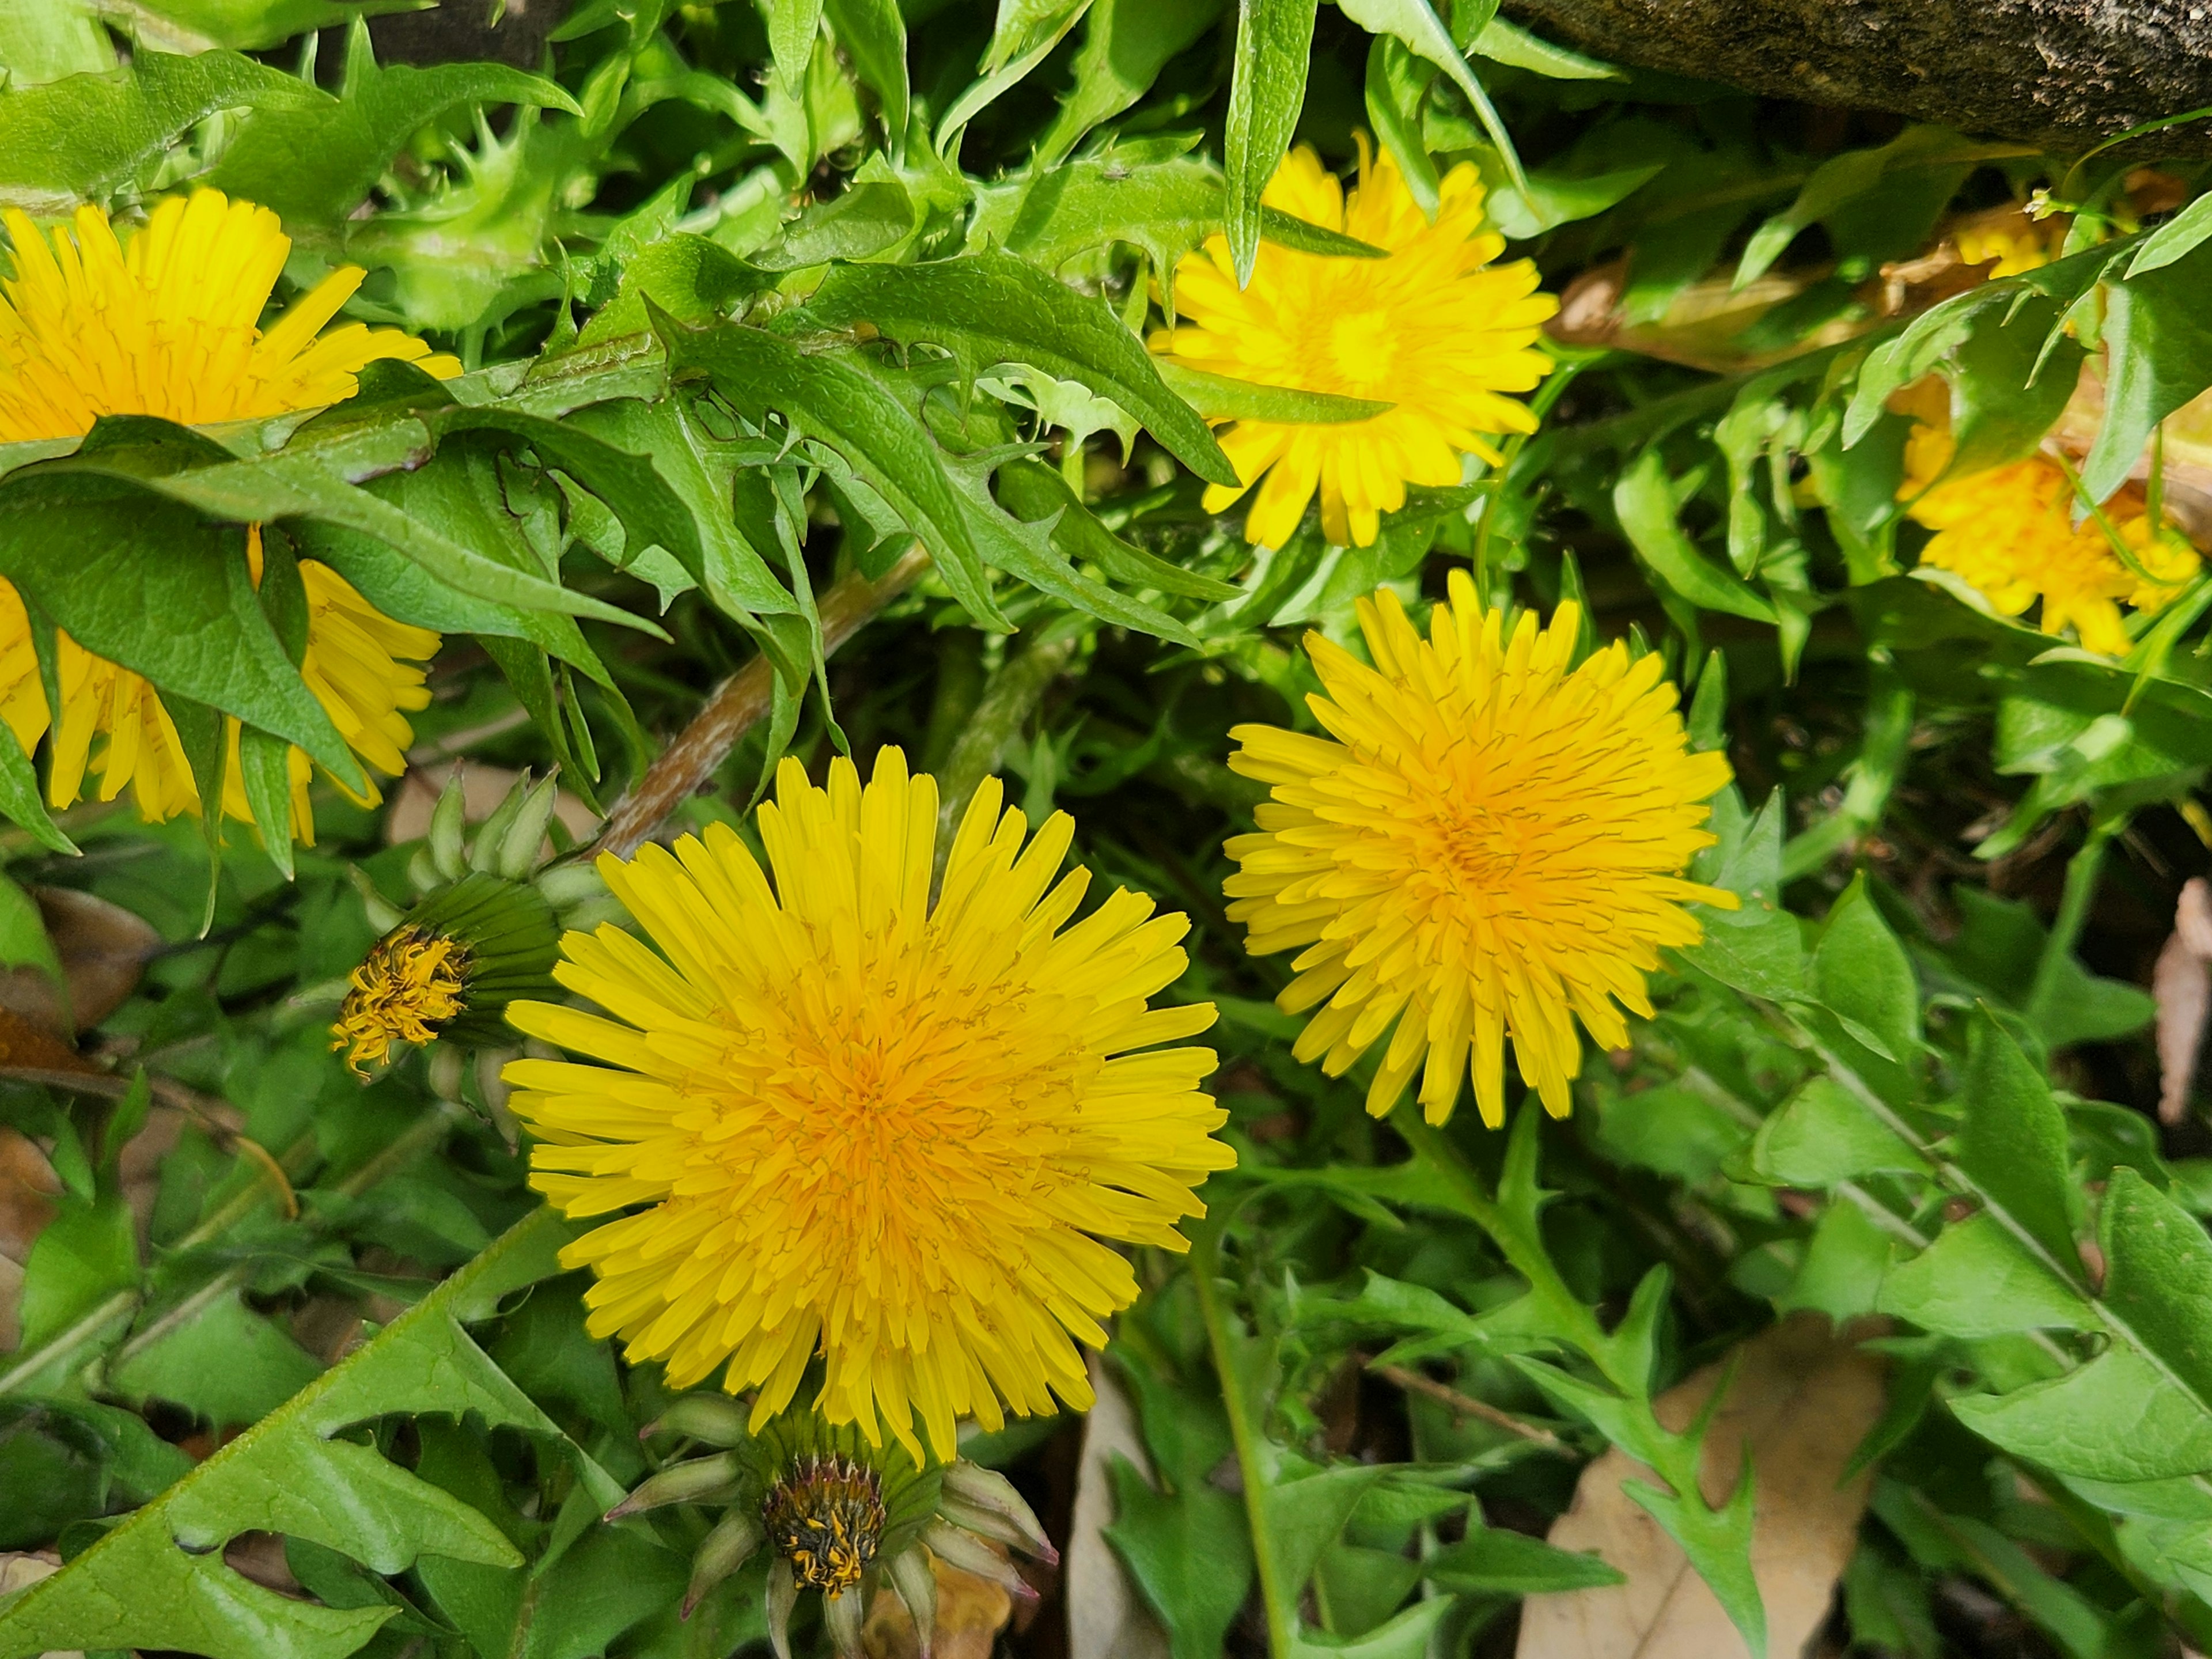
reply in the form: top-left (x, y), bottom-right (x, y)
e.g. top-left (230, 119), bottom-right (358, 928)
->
top-left (0, 190), bottom-right (460, 840)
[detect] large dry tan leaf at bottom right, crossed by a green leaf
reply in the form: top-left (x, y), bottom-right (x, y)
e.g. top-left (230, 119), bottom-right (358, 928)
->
top-left (1517, 1314), bottom-right (1885, 1659)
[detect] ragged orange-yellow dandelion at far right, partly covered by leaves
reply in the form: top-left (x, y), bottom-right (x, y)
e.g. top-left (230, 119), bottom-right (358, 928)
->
top-left (1898, 398), bottom-right (2201, 657)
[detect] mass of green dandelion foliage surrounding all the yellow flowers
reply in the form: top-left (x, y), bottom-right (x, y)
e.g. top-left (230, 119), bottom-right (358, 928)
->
top-left (0, 0), bottom-right (2212, 1659)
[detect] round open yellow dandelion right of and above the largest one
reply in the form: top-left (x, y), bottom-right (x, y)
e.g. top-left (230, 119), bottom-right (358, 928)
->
top-left (1228, 571), bottom-right (1736, 1128)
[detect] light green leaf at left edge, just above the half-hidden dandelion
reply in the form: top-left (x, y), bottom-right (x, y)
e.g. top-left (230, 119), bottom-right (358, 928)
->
top-left (0, 51), bottom-right (336, 213)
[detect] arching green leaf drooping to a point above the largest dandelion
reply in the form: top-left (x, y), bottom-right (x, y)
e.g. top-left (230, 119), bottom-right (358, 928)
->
top-left (661, 319), bottom-right (1011, 630)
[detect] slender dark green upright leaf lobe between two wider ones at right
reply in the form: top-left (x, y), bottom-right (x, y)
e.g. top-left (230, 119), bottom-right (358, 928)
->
top-left (1957, 1011), bottom-right (2081, 1279)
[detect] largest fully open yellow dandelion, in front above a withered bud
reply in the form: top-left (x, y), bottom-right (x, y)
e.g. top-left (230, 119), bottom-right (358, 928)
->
top-left (505, 748), bottom-right (1234, 1458)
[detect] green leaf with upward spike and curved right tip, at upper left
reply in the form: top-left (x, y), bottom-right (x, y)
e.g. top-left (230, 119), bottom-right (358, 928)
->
top-left (208, 18), bottom-right (584, 226)
